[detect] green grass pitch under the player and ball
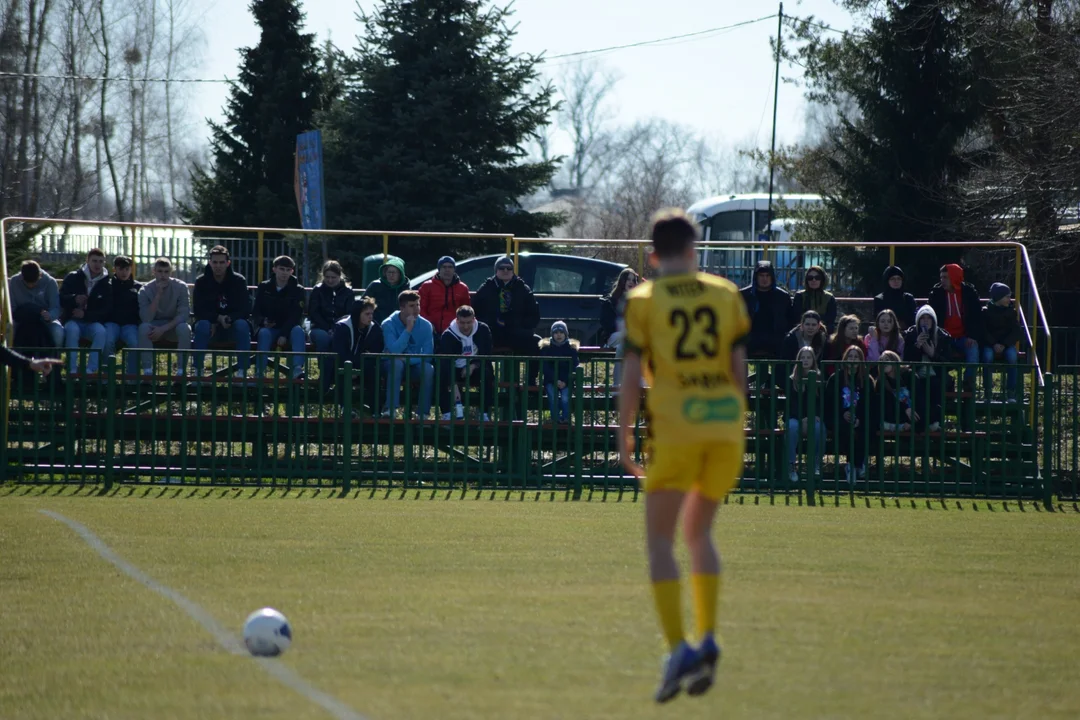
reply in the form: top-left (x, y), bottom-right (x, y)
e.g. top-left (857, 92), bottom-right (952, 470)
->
top-left (0, 488), bottom-right (1080, 720)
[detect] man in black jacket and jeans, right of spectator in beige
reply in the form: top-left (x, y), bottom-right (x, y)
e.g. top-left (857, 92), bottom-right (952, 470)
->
top-left (192, 245), bottom-right (252, 378)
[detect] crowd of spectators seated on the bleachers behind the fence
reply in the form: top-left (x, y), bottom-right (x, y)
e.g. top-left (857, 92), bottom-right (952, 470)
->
top-left (9, 246), bottom-right (1022, 444)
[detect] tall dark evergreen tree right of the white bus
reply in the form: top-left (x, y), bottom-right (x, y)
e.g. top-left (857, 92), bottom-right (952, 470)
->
top-left (798, 0), bottom-right (980, 293)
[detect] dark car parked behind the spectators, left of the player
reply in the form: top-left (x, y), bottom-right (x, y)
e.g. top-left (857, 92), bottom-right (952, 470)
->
top-left (410, 253), bottom-right (626, 344)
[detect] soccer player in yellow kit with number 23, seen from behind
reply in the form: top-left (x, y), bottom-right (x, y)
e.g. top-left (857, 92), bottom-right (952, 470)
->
top-left (619, 209), bottom-right (750, 703)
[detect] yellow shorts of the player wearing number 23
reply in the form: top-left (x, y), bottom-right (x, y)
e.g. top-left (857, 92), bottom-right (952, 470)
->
top-left (645, 437), bottom-right (746, 501)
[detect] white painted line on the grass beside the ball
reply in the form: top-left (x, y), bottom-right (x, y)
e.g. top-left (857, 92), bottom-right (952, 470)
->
top-left (41, 510), bottom-right (367, 720)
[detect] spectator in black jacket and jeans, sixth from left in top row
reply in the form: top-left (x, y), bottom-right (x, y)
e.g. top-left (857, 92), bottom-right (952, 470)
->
top-left (252, 255), bottom-right (308, 380)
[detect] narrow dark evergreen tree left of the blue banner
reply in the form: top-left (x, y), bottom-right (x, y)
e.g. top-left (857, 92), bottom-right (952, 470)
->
top-left (184, 0), bottom-right (326, 239)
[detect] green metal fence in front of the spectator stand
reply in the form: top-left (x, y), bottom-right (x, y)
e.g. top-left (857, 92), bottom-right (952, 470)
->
top-left (0, 350), bottom-right (1049, 504)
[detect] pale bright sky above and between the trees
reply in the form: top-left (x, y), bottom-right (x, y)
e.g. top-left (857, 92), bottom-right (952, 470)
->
top-left (191, 0), bottom-right (851, 148)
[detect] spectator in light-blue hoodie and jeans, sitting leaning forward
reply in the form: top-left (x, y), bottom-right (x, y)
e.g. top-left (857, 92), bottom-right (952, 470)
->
top-left (382, 290), bottom-right (435, 420)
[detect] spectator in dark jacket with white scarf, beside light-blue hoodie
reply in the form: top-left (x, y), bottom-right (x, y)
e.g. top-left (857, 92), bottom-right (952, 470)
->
top-left (438, 305), bottom-right (495, 422)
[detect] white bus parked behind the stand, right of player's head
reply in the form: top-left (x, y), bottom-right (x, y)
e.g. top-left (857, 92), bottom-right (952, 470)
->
top-left (687, 192), bottom-right (823, 287)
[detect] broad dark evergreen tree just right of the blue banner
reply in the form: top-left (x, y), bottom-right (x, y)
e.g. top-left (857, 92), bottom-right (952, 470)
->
top-left (324, 0), bottom-right (562, 277)
